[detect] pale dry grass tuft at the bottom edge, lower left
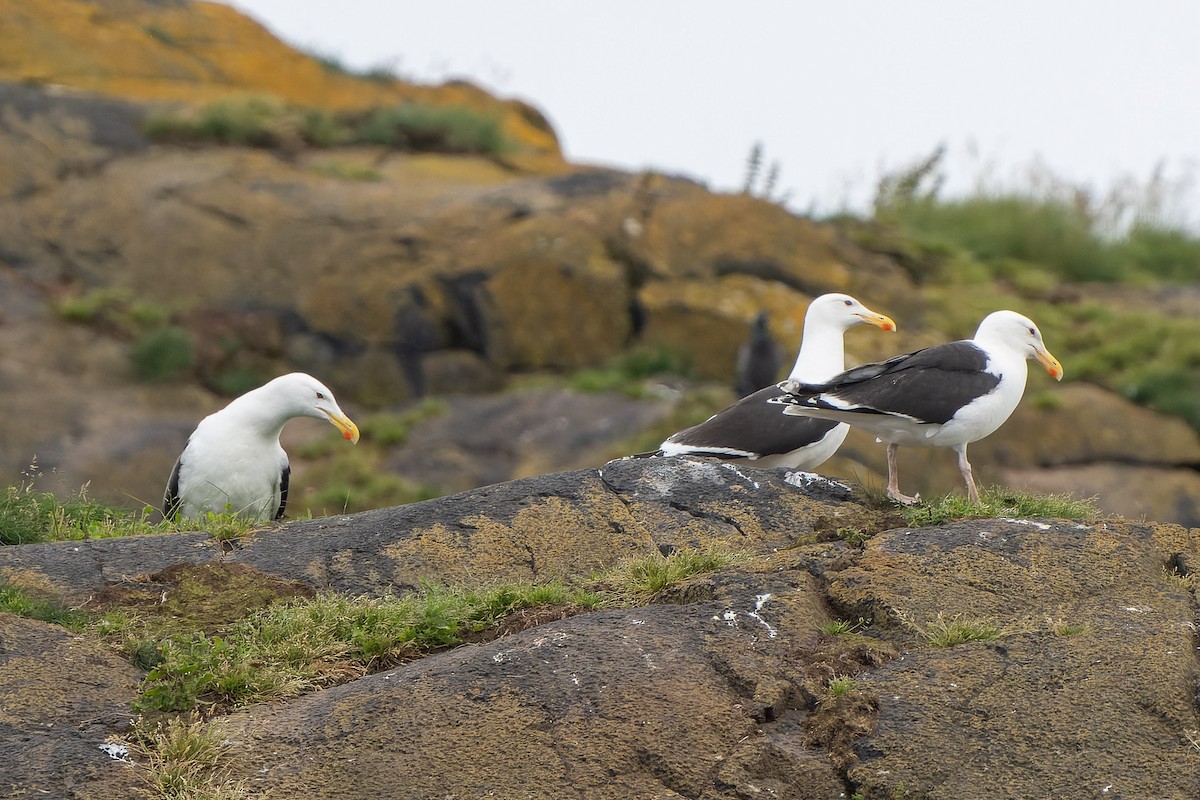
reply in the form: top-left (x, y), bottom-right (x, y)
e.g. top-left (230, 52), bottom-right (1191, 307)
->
top-left (128, 717), bottom-right (248, 800)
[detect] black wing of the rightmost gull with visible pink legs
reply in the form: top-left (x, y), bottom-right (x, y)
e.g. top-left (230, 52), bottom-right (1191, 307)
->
top-left (784, 341), bottom-right (1000, 423)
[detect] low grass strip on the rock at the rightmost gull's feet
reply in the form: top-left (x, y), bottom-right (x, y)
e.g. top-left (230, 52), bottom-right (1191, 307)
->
top-left (900, 487), bottom-right (1100, 528)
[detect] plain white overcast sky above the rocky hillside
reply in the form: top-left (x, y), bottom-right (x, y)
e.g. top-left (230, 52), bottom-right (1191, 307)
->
top-left (220, 0), bottom-right (1200, 223)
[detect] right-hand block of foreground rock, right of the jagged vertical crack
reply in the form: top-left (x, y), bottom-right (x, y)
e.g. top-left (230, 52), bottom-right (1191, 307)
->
top-left (829, 519), bottom-right (1200, 800)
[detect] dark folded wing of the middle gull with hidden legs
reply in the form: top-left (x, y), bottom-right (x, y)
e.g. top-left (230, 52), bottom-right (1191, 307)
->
top-left (667, 386), bottom-right (838, 456)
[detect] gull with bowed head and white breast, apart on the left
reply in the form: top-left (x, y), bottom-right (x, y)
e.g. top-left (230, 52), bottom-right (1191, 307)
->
top-left (162, 372), bottom-right (359, 521)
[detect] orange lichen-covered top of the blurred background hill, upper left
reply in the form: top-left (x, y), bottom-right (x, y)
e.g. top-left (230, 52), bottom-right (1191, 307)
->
top-left (0, 0), bottom-right (562, 158)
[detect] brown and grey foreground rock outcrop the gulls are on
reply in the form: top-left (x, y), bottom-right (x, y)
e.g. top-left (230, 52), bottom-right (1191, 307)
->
top-left (0, 458), bottom-right (1200, 800)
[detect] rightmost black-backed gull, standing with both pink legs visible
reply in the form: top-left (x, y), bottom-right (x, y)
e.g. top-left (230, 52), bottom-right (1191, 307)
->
top-left (773, 311), bottom-right (1062, 505)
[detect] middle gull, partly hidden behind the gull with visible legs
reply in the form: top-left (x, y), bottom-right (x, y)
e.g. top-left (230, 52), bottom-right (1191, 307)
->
top-left (659, 294), bottom-right (896, 470)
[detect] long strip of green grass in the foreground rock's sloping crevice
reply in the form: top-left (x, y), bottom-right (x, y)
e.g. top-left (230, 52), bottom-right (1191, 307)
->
top-left (138, 583), bottom-right (600, 711)
